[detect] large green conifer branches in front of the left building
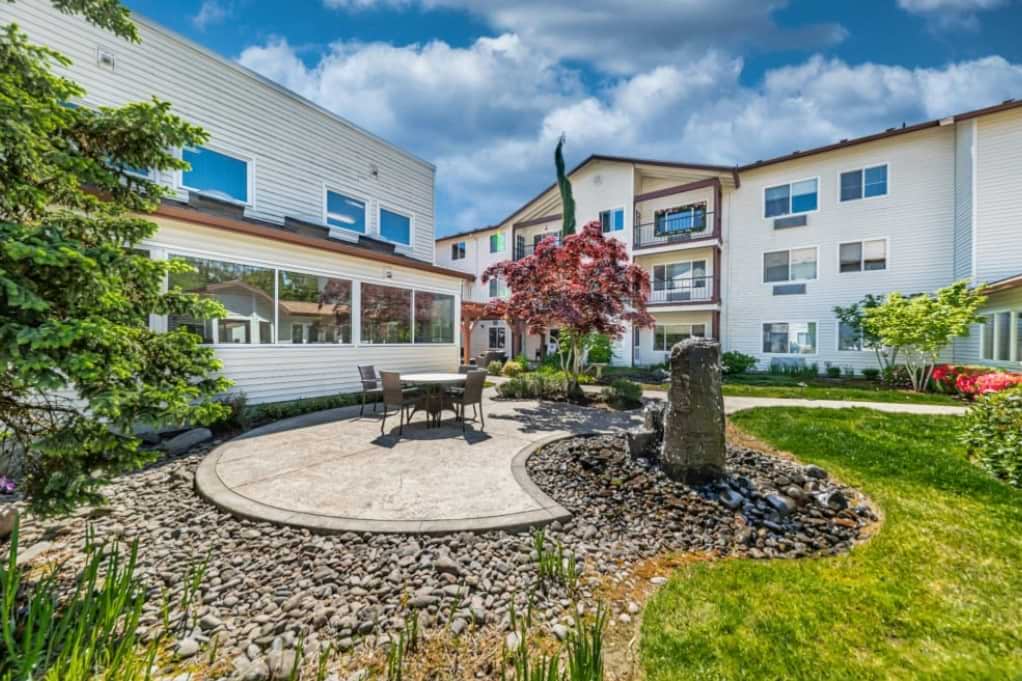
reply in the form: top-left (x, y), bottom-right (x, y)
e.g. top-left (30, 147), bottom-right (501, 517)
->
top-left (0, 0), bottom-right (229, 514)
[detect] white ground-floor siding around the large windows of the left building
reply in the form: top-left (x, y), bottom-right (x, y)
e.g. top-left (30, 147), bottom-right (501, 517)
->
top-left (146, 218), bottom-right (461, 403)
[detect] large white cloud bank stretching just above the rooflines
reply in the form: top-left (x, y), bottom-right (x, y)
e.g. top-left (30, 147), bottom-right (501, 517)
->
top-left (240, 35), bottom-right (1022, 233)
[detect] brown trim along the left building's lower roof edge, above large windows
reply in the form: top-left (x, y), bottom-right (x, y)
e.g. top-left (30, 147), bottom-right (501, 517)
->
top-left (153, 203), bottom-right (475, 281)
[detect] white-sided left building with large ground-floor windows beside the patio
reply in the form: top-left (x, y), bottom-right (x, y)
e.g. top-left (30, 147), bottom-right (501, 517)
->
top-left (0, 0), bottom-right (474, 403)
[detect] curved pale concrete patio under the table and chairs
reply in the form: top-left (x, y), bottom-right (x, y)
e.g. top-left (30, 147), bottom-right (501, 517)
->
top-left (195, 391), bottom-right (639, 534)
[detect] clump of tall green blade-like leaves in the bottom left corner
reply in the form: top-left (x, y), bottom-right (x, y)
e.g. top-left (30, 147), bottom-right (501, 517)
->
top-left (0, 517), bottom-right (202, 681)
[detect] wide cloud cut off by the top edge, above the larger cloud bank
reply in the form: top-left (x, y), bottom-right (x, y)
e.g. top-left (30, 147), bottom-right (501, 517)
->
top-left (324, 0), bottom-right (846, 75)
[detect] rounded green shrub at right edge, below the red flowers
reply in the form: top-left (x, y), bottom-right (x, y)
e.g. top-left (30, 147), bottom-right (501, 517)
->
top-left (962, 384), bottom-right (1022, 487)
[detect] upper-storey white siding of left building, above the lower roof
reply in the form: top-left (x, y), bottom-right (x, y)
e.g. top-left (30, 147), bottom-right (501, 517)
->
top-left (0, 0), bottom-right (434, 262)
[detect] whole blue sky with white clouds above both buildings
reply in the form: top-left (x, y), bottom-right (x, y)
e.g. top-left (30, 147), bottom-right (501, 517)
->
top-left (126, 0), bottom-right (1022, 234)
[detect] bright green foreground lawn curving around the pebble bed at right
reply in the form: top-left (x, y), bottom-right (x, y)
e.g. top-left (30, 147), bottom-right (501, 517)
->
top-left (641, 408), bottom-right (1022, 681)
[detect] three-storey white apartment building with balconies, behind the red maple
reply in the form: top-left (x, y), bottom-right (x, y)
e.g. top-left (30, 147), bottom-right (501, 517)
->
top-left (437, 100), bottom-right (1022, 371)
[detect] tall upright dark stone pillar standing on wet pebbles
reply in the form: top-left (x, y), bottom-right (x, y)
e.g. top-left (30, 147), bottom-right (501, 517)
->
top-left (660, 338), bottom-right (725, 484)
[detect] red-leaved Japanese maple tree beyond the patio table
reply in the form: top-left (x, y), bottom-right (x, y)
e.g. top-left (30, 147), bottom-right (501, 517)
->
top-left (482, 221), bottom-right (654, 395)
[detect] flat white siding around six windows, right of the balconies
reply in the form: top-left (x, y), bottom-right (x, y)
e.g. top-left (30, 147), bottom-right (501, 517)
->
top-left (723, 128), bottom-right (955, 371)
